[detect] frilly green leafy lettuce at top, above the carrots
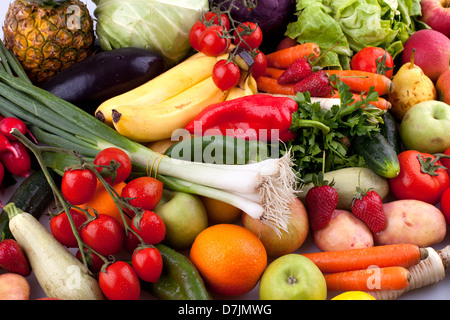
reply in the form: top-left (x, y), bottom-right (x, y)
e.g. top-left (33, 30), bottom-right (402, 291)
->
top-left (285, 0), bottom-right (427, 69)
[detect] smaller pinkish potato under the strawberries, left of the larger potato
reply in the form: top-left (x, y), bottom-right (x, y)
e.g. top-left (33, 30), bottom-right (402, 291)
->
top-left (312, 209), bottom-right (374, 251)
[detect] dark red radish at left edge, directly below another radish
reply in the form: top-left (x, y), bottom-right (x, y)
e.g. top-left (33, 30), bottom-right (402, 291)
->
top-left (0, 141), bottom-right (31, 177)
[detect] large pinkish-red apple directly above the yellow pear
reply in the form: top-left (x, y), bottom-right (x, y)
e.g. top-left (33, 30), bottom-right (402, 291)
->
top-left (400, 29), bottom-right (450, 82)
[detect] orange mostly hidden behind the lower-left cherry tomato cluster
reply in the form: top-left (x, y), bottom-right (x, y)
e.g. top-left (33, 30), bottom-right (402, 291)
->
top-left (80, 180), bottom-right (131, 227)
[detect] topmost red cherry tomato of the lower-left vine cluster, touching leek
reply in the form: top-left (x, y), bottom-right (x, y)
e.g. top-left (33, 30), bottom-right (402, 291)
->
top-left (94, 147), bottom-right (132, 185)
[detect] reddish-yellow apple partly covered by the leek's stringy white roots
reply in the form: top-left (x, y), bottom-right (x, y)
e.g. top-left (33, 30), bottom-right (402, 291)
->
top-left (241, 198), bottom-right (309, 258)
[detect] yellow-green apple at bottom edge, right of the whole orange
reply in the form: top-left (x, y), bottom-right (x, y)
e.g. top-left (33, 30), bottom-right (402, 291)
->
top-left (259, 253), bottom-right (327, 300)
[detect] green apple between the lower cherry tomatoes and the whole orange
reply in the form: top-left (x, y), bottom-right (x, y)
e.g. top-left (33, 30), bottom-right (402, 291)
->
top-left (153, 189), bottom-right (208, 250)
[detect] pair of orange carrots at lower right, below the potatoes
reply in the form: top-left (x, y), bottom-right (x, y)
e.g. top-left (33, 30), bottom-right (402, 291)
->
top-left (303, 244), bottom-right (428, 291)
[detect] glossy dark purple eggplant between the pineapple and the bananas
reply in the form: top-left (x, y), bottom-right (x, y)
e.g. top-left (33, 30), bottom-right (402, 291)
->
top-left (41, 47), bottom-right (166, 112)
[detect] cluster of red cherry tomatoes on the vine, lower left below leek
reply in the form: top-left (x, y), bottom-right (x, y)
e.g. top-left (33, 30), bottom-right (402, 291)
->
top-left (54, 148), bottom-right (166, 300)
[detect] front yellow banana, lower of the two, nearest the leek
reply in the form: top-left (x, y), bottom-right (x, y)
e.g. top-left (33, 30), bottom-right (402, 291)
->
top-left (112, 76), bottom-right (227, 143)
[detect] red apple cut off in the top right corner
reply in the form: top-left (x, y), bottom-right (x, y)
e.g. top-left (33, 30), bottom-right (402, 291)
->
top-left (420, 0), bottom-right (450, 37)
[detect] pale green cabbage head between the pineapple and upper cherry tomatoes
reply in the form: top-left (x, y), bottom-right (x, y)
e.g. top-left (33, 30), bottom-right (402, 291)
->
top-left (93, 0), bottom-right (209, 66)
